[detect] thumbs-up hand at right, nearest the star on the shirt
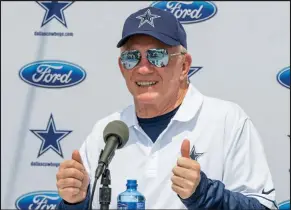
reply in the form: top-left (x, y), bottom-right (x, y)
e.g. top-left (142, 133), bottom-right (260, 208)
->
top-left (171, 140), bottom-right (200, 199)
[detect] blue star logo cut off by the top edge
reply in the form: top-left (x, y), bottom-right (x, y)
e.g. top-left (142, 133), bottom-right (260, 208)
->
top-left (37, 1), bottom-right (73, 28)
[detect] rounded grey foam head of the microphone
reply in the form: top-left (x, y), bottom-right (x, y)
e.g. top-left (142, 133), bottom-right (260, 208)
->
top-left (103, 120), bottom-right (129, 149)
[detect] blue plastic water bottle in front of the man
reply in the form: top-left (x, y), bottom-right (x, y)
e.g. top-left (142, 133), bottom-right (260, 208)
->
top-left (117, 180), bottom-right (145, 209)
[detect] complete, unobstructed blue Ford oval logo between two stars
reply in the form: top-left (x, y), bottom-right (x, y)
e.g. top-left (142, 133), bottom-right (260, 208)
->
top-left (19, 60), bottom-right (86, 88)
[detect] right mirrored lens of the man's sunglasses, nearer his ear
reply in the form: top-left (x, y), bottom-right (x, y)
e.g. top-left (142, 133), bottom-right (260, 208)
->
top-left (147, 49), bottom-right (169, 67)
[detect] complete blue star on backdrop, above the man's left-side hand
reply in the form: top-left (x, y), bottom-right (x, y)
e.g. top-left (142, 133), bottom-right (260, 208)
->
top-left (30, 114), bottom-right (72, 158)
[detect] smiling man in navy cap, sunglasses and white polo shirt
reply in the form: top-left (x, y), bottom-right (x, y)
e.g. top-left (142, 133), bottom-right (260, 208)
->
top-left (57, 7), bottom-right (277, 210)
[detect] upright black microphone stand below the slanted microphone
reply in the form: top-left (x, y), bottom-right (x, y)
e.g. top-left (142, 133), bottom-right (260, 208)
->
top-left (99, 168), bottom-right (111, 210)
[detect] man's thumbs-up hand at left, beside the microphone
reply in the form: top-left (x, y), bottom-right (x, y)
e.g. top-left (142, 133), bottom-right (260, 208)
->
top-left (56, 150), bottom-right (89, 204)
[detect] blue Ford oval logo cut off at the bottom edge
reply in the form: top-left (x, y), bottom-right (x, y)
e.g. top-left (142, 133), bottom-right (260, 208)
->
top-left (15, 191), bottom-right (62, 210)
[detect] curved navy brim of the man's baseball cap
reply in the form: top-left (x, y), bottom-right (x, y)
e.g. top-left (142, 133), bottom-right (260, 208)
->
top-left (117, 31), bottom-right (181, 48)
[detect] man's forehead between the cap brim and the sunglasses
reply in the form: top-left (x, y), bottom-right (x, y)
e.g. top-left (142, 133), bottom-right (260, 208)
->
top-left (121, 34), bottom-right (173, 51)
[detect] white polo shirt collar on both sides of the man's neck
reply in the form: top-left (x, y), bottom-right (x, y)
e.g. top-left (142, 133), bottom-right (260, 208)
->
top-left (120, 83), bottom-right (203, 127)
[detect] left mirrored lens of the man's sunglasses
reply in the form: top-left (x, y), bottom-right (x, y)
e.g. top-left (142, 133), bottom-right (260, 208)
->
top-left (120, 50), bottom-right (141, 70)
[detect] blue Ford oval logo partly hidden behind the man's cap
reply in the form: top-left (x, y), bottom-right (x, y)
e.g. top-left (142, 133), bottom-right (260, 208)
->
top-left (151, 1), bottom-right (217, 24)
